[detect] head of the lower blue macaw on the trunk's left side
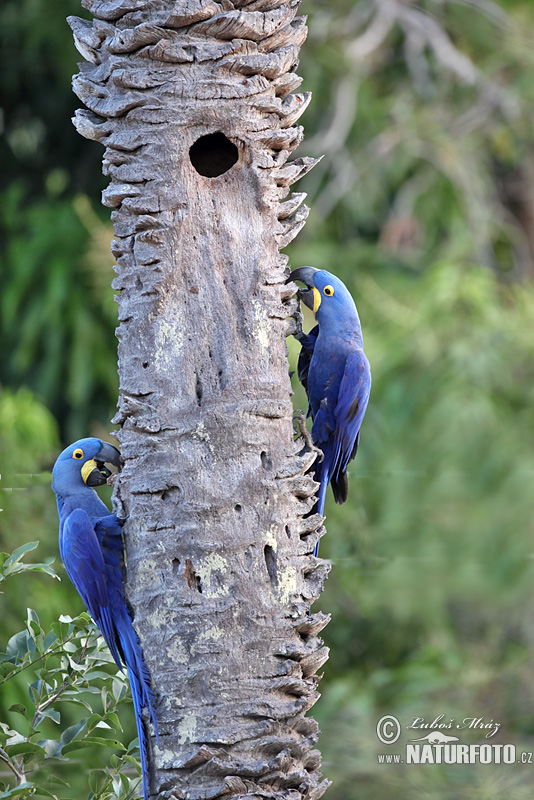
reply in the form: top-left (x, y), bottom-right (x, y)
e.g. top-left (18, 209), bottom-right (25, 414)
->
top-left (52, 437), bottom-right (120, 497)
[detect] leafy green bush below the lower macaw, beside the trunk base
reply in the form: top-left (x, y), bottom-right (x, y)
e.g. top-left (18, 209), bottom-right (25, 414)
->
top-left (0, 542), bottom-right (141, 800)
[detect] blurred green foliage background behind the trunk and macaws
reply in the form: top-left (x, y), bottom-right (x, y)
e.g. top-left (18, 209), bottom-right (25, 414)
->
top-left (0, 0), bottom-right (534, 800)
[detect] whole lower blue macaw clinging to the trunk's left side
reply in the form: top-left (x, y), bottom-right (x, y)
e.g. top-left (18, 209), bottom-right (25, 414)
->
top-left (52, 438), bottom-right (158, 800)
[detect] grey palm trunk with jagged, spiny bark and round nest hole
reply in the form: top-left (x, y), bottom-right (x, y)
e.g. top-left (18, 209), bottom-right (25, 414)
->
top-left (69, 0), bottom-right (328, 800)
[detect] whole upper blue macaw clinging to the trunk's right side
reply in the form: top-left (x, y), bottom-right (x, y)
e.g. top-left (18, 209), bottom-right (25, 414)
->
top-left (288, 267), bottom-right (371, 556)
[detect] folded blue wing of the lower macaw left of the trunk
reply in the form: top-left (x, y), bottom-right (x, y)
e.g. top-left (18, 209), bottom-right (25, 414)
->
top-left (60, 508), bottom-right (122, 669)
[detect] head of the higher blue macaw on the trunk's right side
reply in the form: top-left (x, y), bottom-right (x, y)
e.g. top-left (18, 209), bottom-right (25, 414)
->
top-left (288, 267), bottom-right (360, 326)
